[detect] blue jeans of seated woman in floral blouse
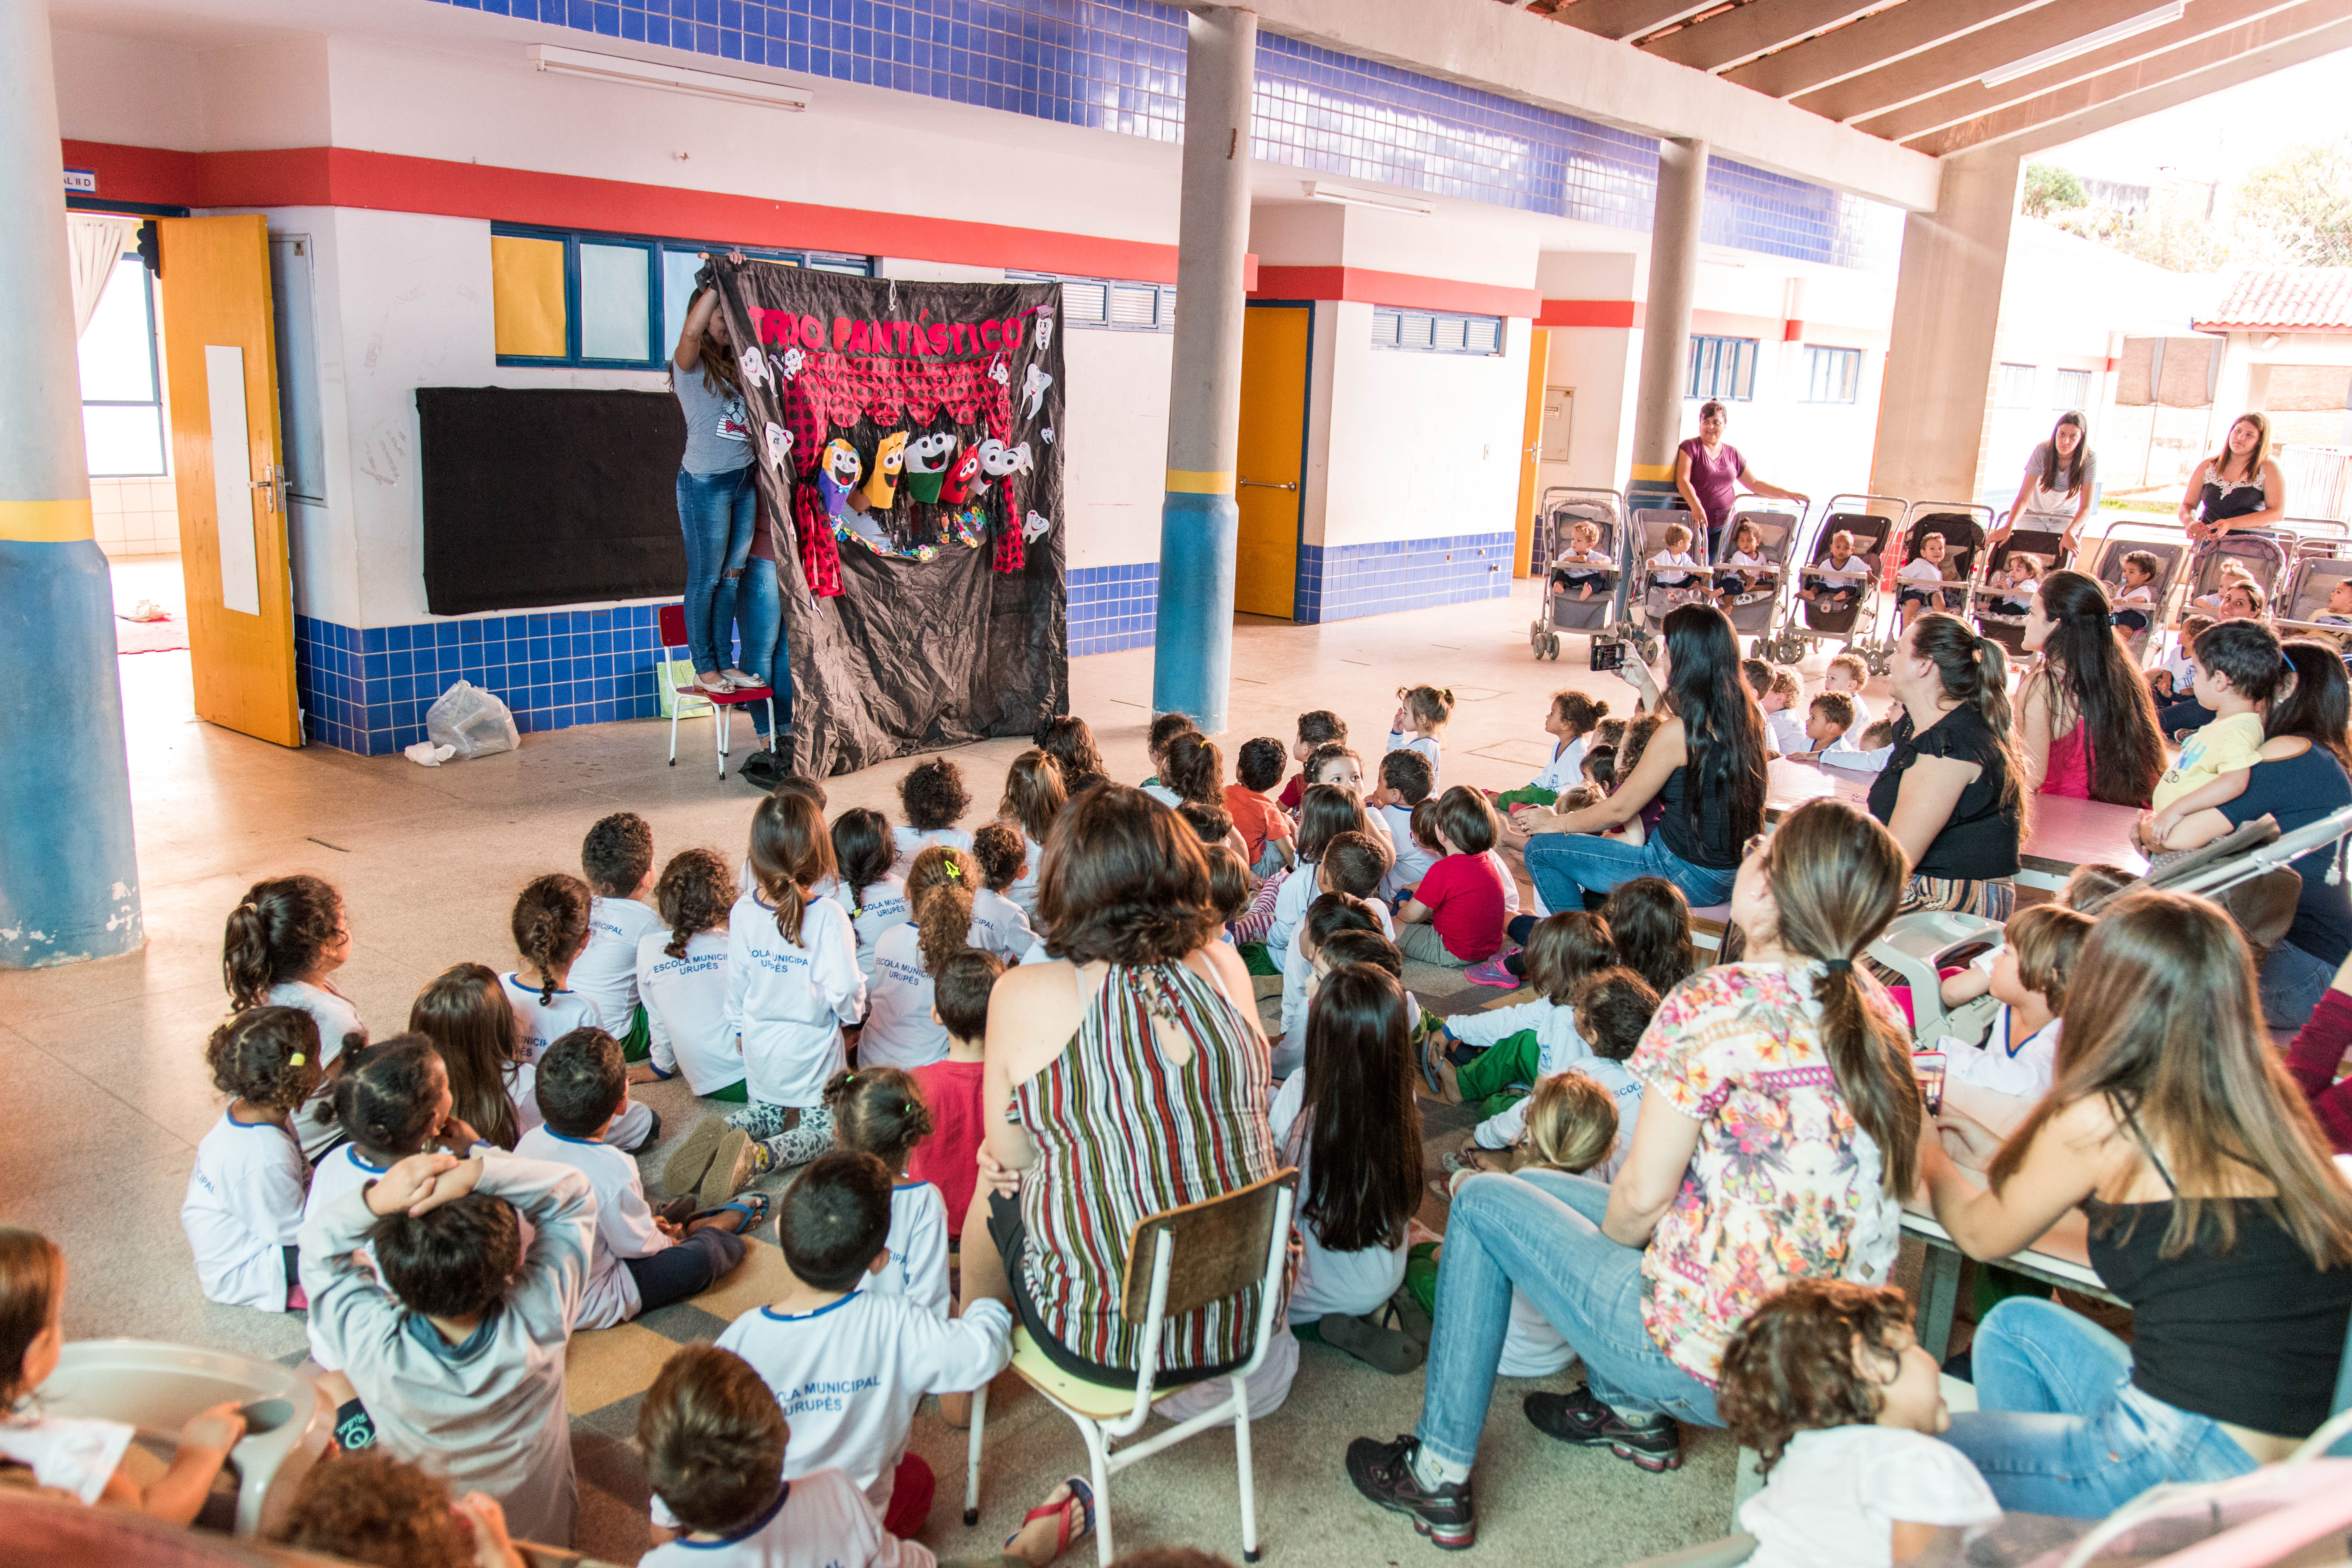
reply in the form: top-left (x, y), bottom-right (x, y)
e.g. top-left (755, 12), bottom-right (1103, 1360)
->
top-left (1414, 1171), bottom-right (1724, 1465)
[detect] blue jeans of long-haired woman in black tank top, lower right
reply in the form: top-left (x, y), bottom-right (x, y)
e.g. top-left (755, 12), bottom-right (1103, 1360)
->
top-left (1943, 1295), bottom-right (2256, 1519)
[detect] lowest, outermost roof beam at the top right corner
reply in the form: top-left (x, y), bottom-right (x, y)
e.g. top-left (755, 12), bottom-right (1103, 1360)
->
top-left (1910, 0), bottom-right (2352, 155)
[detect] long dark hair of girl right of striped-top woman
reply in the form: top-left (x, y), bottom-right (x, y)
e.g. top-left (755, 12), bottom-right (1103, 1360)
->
top-left (1291, 964), bottom-right (1421, 1253)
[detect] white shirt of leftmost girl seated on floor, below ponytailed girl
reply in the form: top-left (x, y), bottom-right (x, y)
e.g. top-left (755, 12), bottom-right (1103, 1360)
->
top-left (179, 1105), bottom-right (310, 1312)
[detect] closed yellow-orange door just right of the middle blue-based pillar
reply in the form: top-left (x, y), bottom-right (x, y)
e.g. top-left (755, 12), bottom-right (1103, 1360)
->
top-left (1232, 306), bottom-right (1315, 621)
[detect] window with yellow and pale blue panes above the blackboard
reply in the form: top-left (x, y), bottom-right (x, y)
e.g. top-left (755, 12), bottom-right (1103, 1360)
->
top-left (489, 223), bottom-right (873, 369)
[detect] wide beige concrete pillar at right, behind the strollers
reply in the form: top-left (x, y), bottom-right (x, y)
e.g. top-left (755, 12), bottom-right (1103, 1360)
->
top-left (1870, 151), bottom-right (2023, 501)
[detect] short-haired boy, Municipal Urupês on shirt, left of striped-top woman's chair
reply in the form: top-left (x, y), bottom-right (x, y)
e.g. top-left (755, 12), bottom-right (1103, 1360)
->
top-left (717, 1150), bottom-right (1011, 1535)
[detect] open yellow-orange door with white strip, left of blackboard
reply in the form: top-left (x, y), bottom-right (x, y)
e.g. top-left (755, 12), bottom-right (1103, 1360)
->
top-left (158, 214), bottom-right (301, 745)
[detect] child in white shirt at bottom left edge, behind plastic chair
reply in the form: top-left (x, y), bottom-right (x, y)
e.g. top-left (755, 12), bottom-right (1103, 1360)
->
top-left (0, 1225), bottom-right (245, 1523)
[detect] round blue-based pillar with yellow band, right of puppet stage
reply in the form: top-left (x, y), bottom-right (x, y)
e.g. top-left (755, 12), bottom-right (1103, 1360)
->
top-left (1152, 7), bottom-right (1258, 733)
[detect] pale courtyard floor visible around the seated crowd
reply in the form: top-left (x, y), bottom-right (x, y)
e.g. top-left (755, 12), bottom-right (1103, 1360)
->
top-left (18, 583), bottom-right (1900, 1568)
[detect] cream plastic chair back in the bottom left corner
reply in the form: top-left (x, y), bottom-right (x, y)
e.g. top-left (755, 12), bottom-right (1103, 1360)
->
top-left (35, 1340), bottom-right (334, 1556)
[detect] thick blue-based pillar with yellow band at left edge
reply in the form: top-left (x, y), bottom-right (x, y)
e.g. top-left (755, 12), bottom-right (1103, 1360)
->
top-left (0, 0), bottom-right (146, 969)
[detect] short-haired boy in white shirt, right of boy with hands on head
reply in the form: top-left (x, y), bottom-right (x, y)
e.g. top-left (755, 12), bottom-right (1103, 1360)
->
top-left (515, 1030), bottom-right (767, 1328)
